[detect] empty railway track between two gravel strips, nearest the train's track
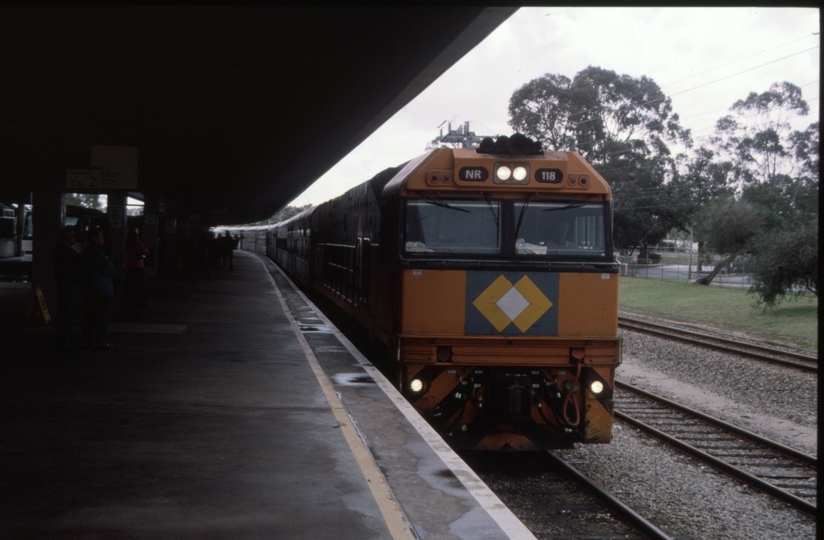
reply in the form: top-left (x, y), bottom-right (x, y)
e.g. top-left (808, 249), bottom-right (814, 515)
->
top-left (615, 381), bottom-right (818, 516)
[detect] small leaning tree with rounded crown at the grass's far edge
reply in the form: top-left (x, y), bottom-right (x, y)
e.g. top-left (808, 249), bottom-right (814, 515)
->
top-left (696, 198), bottom-right (775, 285)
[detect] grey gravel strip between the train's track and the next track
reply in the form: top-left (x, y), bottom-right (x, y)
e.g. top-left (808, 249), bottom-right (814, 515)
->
top-left (557, 422), bottom-right (815, 540)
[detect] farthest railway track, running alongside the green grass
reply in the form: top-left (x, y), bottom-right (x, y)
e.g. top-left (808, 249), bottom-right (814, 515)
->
top-left (618, 317), bottom-right (818, 373)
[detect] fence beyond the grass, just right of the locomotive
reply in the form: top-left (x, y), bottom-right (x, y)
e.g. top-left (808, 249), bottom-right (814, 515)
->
top-left (618, 245), bottom-right (752, 289)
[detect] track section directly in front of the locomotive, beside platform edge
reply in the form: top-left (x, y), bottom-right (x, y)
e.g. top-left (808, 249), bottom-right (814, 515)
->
top-left (461, 452), bottom-right (672, 540)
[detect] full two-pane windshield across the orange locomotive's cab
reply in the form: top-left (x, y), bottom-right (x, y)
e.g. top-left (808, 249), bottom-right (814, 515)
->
top-left (403, 199), bottom-right (609, 259)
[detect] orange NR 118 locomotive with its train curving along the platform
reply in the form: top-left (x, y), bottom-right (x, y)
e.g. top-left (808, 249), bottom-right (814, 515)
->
top-left (222, 134), bottom-right (621, 451)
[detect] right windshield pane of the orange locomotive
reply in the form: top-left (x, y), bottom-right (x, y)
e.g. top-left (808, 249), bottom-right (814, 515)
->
top-left (515, 202), bottom-right (606, 257)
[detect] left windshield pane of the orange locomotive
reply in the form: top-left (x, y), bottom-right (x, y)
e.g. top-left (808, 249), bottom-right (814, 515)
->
top-left (404, 199), bottom-right (501, 254)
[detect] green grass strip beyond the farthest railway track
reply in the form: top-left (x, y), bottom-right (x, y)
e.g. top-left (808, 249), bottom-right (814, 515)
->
top-left (618, 277), bottom-right (818, 351)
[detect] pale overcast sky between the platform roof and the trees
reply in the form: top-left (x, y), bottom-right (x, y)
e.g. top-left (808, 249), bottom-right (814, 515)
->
top-left (290, 7), bottom-right (821, 206)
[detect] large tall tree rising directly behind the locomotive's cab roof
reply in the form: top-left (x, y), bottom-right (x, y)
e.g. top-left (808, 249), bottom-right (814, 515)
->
top-left (509, 66), bottom-right (691, 251)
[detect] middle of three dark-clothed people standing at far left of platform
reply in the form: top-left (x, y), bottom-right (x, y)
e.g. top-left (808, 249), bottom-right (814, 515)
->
top-left (83, 229), bottom-right (117, 349)
